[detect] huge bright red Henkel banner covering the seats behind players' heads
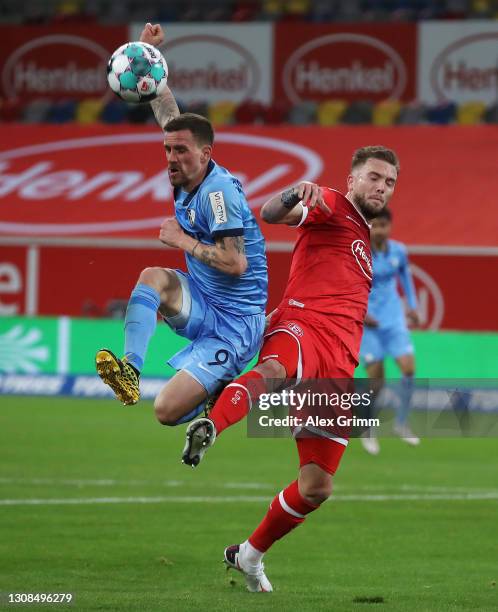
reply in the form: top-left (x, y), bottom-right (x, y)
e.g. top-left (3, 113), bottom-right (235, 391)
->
top-left (0, 125), bottom-right (498, 247)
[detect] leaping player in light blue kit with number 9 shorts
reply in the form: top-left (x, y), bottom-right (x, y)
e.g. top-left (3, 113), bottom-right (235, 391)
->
top-left (96, 24), bottom-right (268, 425)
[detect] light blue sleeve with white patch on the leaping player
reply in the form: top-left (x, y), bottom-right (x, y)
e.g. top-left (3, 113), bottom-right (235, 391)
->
top-left (202, 180), bottom-right (244, 238)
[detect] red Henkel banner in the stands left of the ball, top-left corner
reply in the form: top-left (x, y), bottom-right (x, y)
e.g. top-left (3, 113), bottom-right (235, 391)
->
top-left (0, 24), bottom-right (128, 102)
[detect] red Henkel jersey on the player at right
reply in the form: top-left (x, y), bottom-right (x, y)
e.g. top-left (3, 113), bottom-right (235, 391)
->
top-left (279, 187), bottom-right (372, 359)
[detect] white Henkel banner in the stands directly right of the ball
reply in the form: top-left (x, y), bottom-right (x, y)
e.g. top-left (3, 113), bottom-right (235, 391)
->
top-left (128, 24), bottom-right (271, 103)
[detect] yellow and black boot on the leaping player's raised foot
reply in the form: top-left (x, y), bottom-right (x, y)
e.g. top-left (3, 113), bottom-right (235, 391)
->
top-left (95, 349), bottom-right (140, 406)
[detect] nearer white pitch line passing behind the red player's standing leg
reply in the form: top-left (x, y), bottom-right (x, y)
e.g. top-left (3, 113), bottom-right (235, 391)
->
top-left (0, 491), bottom-right (498, 506)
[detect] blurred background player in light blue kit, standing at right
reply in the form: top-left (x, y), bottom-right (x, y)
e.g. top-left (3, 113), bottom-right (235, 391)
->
top-left (360, 208), bottom-right (420, 455)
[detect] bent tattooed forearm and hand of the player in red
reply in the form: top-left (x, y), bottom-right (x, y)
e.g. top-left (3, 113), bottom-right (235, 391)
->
top-left (261, 181), bottom-right (330, 225)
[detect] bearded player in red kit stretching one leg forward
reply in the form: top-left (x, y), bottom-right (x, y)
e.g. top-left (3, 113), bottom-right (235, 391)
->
top-left (183, 146), bottom-right (399, 592)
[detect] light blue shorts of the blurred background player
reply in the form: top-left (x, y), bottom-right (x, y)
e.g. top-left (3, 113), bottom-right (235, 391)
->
top-left (360, 325), bottom-right (414, 365)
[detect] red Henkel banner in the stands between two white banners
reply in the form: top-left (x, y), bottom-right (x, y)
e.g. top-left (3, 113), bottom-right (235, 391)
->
top-left (274, 23), bottom-right (417, 104)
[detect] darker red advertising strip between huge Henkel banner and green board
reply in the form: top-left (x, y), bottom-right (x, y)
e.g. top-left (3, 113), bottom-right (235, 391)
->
top-left (0, 245), bottom-right (498, 331)
